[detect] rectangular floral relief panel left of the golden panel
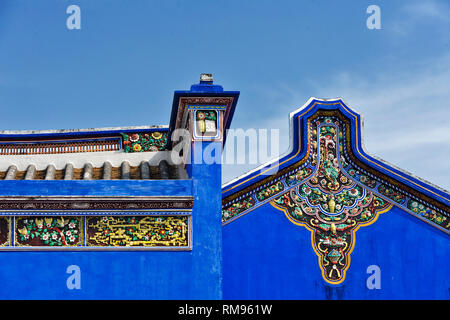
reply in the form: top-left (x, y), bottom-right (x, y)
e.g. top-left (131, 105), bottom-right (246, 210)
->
top-left (16, 217), bottom-right (80, 247)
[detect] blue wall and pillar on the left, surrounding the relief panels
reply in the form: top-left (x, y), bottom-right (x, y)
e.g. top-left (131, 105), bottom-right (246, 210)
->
top-left (0, 144), bottom-right (222, 299)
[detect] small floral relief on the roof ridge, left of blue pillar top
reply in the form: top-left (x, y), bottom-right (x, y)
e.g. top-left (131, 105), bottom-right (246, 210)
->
top-left (121, 131), bottom-right (168, 152)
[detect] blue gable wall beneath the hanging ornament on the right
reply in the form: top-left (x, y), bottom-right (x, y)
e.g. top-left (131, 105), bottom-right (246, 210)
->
top-left (223, 204), bottom-right (450, 299)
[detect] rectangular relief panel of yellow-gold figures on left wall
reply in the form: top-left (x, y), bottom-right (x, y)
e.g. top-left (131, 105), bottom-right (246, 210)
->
top-left (87, 216), bottom-right (189, 247)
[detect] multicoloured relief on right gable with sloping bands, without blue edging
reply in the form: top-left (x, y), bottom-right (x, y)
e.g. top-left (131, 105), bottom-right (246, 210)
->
top-left (222, 110), bottom-right (450, 284)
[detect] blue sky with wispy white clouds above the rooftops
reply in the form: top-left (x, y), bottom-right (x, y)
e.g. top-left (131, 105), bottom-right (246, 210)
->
top-left (0, 0), bottom-right (450, 190)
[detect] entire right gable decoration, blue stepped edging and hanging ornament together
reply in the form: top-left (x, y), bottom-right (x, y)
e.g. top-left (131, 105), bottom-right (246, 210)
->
top-left (222, 99), bottom-right (450, 284)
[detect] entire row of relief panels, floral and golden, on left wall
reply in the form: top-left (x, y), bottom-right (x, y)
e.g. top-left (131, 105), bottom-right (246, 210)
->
top-left (0, 216), bottom-right (190, 248)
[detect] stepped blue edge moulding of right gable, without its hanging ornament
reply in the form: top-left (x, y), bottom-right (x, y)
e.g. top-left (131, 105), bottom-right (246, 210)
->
top-left (222, 97), bottom-right (450, 233)
